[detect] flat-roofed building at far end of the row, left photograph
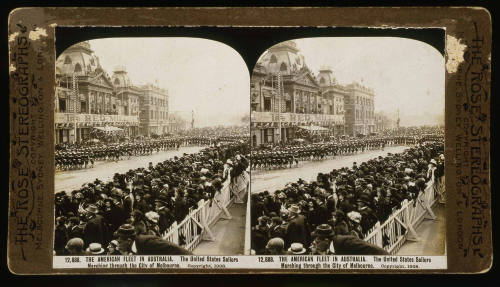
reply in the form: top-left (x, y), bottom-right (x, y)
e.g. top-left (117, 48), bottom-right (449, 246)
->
top-left (140, 83), bottom-right (169, 136)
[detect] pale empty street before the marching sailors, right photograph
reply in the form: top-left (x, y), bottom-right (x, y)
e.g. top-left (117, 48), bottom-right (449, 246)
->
top-left (250, 146), bottom-right (407, 196)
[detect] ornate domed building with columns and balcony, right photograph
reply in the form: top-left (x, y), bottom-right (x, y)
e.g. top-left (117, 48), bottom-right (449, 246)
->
top-left (250, 41), bottom-right (343, 145)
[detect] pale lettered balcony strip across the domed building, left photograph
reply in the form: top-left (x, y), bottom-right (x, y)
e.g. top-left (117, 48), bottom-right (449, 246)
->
top-left (54, 113), bottom-right (139, 126)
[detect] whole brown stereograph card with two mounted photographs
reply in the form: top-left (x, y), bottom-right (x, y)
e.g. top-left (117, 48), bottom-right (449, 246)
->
top-left (7, 7), bottom-right (493, 274)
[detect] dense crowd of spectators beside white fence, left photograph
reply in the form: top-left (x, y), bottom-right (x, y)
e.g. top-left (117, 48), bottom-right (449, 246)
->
top-left (54, 141), bottom-right (249, 255)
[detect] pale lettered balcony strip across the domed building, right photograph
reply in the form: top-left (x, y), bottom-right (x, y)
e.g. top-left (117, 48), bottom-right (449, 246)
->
top-left (250, 112), bottom-right (345, 125)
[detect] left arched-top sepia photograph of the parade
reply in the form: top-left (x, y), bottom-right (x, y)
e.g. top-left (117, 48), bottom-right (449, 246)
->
top-left (53, 38), bottom-right (250, 256)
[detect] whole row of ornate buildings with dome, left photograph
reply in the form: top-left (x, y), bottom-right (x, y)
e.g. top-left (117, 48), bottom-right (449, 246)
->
top-left (54, 41), bottom-right (172, 143)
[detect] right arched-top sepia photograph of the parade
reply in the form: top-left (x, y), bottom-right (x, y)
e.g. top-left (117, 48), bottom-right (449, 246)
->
top-left (250, 37), bottom-right (446, 256)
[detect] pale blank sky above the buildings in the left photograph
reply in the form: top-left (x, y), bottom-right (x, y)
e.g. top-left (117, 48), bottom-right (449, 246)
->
top-left (89, 38), bottom-right (250, 127)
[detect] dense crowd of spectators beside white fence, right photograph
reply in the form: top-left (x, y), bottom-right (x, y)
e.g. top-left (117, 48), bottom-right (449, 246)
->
top-left (251, 138), bottom-right (444, 255)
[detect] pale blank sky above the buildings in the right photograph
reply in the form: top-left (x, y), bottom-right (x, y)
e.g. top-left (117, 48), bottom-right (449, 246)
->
top-left (295, 37), bottom-right (445, 126)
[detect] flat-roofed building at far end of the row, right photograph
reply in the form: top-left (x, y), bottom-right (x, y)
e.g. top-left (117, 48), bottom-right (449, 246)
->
top-left (344, 83), bottom-right (375, 136)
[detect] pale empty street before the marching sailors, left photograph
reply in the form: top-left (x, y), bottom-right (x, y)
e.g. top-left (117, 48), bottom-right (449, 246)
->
top-left (54, 147), bottom-right (203, 192)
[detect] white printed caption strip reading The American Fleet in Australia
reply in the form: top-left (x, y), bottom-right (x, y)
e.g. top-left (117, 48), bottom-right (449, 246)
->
top-left (54, 255), bottom-right (447, 271)
